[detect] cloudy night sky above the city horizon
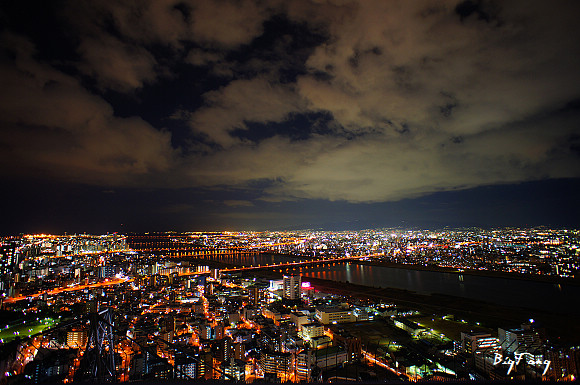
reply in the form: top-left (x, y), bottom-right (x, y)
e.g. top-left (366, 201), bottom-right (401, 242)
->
top-left (0, 0), bottom-right (580, 233)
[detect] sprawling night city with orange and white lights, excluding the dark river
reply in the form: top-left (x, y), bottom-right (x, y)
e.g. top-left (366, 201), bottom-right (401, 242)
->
top-left (0, 228), bottom-right (580, 384)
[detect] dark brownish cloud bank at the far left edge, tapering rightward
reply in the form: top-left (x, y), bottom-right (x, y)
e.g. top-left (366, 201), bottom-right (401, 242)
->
top-left (0, 33), bottom-right (176, 185)
